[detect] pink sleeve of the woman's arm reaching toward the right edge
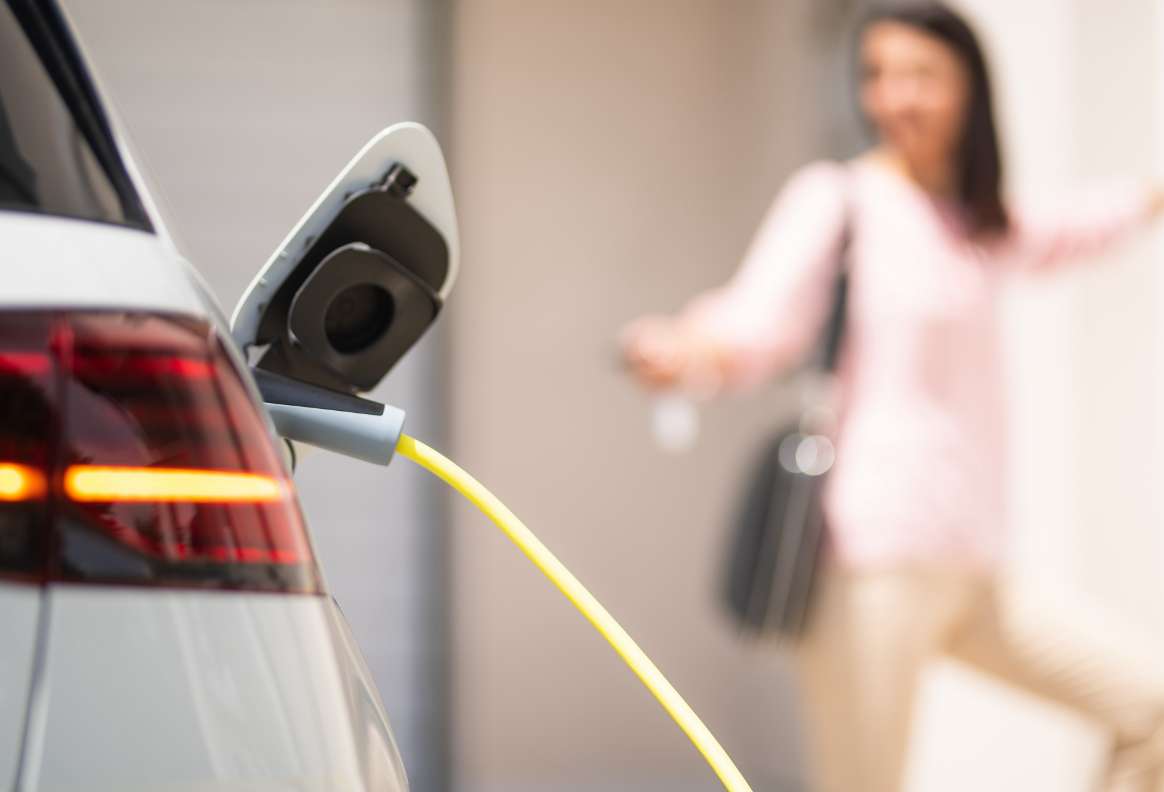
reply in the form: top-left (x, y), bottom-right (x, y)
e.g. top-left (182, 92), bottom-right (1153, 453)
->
top-left (1012, 186), bottom-right (1151, 270)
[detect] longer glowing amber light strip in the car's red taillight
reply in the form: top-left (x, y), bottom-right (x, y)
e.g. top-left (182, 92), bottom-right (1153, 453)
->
top-left (64, 465), bottom-right (286, 503)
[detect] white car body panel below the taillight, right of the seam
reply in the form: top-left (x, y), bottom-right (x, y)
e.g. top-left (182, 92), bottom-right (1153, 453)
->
top-left (24, 586), bottom-right (406, 792)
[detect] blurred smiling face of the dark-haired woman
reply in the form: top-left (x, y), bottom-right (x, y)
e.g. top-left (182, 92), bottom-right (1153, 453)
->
top-left (860, 21), bottom-right (970, 173)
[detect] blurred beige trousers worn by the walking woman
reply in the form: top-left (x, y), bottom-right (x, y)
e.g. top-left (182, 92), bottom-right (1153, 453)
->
top-left (796, 568), bottom-right (1164, 792)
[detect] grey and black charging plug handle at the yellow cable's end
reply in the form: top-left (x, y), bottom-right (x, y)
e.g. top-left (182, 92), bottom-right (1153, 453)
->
top-left (251, 368), bottom-right (404, 465)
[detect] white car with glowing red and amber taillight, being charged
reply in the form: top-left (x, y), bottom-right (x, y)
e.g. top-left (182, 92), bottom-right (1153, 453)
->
top-left (0, 0), bottom-right (444, 792)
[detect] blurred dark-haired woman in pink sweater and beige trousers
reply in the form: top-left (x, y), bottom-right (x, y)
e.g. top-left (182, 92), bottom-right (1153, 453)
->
top-left (624, 2), bottom-right (1164, 792)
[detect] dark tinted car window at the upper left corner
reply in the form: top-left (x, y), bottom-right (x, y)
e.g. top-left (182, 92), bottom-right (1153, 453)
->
top-left (0, 3), bottom-right (136, 225)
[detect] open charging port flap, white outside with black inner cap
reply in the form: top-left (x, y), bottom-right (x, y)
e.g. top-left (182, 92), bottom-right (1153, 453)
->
top-left (230, 123), bottom-right (460, 395)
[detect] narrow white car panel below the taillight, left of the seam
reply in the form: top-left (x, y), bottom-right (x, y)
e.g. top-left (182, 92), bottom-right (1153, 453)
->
top-left (0, 584), bottom-right (41, 784)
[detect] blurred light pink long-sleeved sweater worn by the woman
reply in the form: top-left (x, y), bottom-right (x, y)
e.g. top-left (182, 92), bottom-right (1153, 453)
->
top-left (683, 162), bottom-right (1149, 568)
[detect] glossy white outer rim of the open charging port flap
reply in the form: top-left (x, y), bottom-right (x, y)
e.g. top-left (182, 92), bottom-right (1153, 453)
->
top-left (230, 122), bottom-right (461, 349)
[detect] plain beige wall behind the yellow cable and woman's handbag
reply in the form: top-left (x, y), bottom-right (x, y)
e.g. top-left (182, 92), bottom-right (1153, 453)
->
top-left (449, 0), bottom-right (845, 790)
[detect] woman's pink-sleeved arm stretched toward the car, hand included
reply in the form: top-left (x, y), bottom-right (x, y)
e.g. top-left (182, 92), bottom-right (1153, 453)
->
top-left (623, 163), bottom-right (850, 390)
